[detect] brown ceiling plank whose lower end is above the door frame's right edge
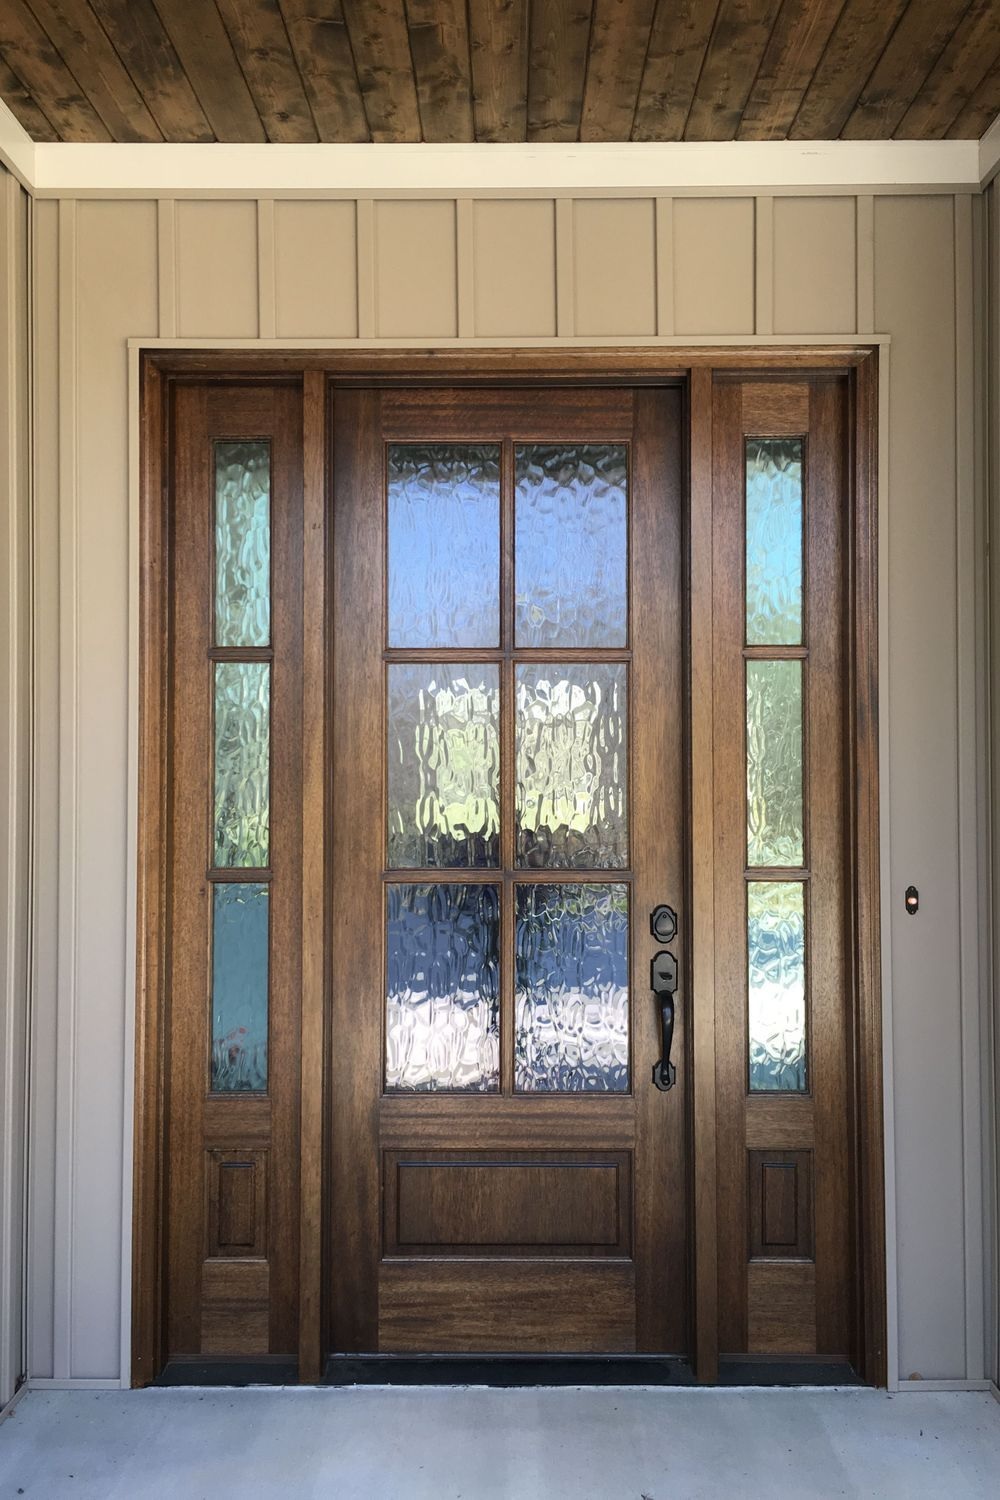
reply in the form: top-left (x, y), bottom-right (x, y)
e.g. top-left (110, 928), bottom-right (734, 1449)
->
top-left (841, 0), bottom-right (969, 141)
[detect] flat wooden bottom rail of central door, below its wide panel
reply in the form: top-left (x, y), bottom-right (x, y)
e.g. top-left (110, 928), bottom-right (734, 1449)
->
top-left (379, 1260), bottom-right (636, 1355)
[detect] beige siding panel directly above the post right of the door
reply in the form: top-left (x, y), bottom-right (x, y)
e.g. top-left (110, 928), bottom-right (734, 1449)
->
top-left (673, 198), bottom-right (754, 335)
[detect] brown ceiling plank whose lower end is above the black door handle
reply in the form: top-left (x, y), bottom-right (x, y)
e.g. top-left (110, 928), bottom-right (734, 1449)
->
top-left (633, 0), bottom-right (718, 141)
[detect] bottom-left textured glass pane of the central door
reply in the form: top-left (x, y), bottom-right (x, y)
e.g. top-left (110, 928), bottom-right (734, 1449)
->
top-left (385, 885), bottom-right (499, 1094)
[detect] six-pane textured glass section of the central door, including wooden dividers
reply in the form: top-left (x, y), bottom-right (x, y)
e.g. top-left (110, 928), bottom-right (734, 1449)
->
top-left (384, 440), bottom-right (631, 1094)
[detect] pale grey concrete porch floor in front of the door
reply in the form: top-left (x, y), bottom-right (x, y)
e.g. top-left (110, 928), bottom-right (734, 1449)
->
top-left (0, 1386), bottom-right (1000, 1500)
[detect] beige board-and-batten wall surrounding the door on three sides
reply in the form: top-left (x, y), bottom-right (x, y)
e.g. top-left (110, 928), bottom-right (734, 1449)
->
top-left (23, 192), bottom-right (985, 1380)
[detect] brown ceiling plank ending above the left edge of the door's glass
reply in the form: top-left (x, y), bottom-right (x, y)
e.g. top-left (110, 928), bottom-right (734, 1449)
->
top-left (342, 0), bottom-right (420, 141)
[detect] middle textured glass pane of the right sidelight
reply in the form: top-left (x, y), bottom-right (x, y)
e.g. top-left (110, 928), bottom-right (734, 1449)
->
top-left (747, 662), bottom-right (804, 866)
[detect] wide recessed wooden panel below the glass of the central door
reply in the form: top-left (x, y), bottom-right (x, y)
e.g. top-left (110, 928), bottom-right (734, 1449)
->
top-left (384, 1151), bottom-right (631, 1256)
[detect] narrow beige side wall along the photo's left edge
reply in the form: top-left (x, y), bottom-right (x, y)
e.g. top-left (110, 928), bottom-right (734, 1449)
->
top-left (0, 158), bottom-right (31, 1407)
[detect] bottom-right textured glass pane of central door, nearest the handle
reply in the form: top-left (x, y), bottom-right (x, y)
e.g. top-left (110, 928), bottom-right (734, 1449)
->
top-left (514, 885), bottom-right (628, 1094)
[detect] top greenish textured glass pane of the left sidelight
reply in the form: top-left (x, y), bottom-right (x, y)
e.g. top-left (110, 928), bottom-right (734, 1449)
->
top-left (216, 443), bottom-right (271, 647)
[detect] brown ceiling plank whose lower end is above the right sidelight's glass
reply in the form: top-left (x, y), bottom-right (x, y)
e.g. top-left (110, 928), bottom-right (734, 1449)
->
top-left (736, 0), bottom-right (843, 141)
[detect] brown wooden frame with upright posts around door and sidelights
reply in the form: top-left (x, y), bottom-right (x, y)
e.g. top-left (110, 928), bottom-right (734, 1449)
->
top-left (132, 342), bottom-right (888, 1386)
